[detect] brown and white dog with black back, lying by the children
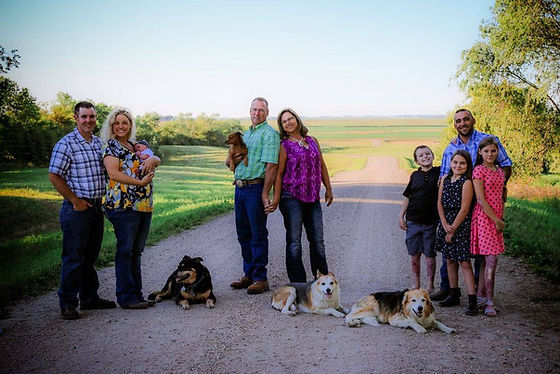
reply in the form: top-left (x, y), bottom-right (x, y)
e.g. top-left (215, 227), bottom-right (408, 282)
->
top-left (346, 289), bottom-right (455, 334)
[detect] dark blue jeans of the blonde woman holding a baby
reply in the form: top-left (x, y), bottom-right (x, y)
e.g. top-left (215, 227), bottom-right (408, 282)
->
top-left (105, 209), bottom-right (152, 307)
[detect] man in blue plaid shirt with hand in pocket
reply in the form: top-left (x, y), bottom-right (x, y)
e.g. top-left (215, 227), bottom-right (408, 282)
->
top-left (49, 101), bottom-right (116, 320)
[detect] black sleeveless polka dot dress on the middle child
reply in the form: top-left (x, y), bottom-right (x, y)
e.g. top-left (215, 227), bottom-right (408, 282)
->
top-left (436, 175), bottom-right (472, 261)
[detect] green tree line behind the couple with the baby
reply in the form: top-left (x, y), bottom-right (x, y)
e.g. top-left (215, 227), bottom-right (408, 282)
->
top-left (0, 76), bottom-right (242, 165)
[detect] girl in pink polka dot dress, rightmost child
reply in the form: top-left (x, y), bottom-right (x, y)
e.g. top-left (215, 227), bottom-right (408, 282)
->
top-left (471, 136), bottom-right (505, 317)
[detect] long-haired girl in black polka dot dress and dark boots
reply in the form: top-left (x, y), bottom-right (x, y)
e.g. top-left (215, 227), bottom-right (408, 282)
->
top-left (436, 150), bottom-right (478, 316)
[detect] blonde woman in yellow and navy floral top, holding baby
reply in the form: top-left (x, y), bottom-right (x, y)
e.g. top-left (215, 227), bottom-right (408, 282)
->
top-left (101, 108), bottom-right (160, 309)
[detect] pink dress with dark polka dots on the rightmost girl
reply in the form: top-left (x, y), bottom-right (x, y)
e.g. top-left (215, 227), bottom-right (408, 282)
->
top-left (471, 165), bottom-right (505, 256)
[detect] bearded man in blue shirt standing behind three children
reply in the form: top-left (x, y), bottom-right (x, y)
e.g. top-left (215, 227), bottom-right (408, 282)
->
top-left (430, 109), bottom-right (512, 301)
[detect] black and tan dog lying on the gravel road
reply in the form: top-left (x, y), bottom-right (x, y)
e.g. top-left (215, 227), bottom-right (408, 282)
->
top-left (148, 256), bottom-right (216, 309)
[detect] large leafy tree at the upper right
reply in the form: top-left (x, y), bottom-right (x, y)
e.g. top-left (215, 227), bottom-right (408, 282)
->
top-left (456, 0), bottom-right (560, 174)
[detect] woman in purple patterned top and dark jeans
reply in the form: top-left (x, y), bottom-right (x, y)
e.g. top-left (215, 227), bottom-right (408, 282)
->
top-left (265, 109), bottom-right (333, 282)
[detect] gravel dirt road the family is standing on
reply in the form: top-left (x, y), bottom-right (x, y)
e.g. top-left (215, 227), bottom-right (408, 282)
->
top-left (0, 157), bottom-right (560, 373)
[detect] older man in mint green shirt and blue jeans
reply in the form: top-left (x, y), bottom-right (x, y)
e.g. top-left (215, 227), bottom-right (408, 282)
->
top-left (231, 97), bottom-right (280, 294)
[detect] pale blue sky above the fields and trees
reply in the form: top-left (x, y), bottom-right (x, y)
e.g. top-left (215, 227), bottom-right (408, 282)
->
top-left (0, 0), bottom-right (492, 117)
